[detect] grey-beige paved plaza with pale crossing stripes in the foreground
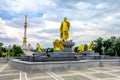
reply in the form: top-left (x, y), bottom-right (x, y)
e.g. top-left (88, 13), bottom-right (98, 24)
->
top-left (0, 63), bottom-right (120, 80)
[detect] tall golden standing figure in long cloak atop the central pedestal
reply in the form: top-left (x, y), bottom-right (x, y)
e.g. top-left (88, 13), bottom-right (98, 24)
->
top-left (60, 17), bottom-right (70, 41)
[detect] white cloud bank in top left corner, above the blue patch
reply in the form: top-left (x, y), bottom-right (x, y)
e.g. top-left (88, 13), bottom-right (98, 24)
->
top-left (0, 0), bottom-right (55, 13)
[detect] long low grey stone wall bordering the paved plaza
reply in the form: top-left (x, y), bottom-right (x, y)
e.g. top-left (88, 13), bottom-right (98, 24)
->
top-left (9, 59), bottom-right (120, 72)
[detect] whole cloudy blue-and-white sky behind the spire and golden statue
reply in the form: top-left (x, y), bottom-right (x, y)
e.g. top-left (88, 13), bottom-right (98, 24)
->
top-left (0, 0), bottom-right (120, 48)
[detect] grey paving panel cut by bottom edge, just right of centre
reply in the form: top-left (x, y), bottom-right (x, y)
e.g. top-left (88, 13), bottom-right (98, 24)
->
top-left (62, 75), bottom-right (91, 80)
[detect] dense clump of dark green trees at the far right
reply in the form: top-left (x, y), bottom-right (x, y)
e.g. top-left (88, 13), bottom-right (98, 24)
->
top-left (93, 36), bottom-right (120, 56)
